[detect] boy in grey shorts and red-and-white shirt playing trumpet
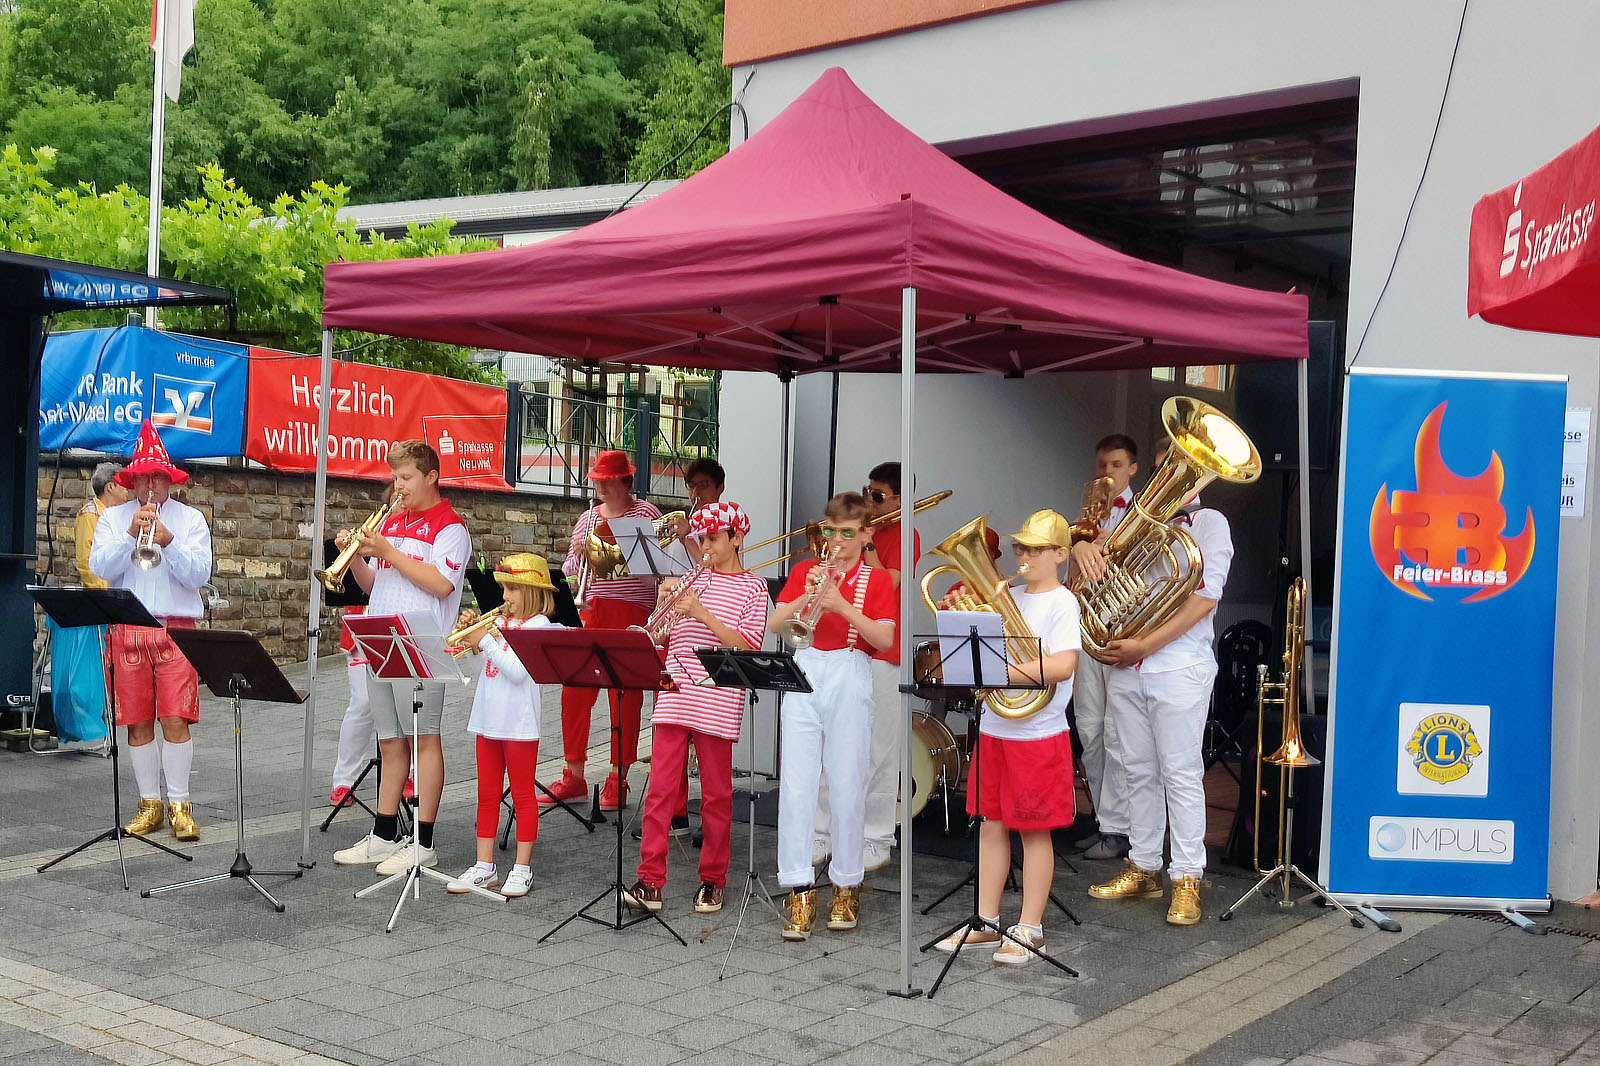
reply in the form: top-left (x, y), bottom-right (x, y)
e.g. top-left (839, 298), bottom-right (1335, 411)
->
top-left (333, 440), bottom-right (472, 877)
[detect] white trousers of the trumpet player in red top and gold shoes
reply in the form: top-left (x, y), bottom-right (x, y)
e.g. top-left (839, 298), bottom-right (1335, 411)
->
top-left (778, 648), bottom-right (872, 888)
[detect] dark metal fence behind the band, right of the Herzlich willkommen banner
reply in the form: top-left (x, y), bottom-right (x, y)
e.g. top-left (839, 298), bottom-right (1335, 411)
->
top-left (507, 383), bottom-right (717, 499)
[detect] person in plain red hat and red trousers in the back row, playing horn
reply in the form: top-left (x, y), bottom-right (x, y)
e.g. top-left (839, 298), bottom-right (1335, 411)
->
top-left (539, 451), bottom-right (661, 810)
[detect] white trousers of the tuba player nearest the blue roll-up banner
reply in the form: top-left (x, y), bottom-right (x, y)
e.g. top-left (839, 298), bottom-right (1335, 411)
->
top-left (1106, 663), bottom-right (1216, 877)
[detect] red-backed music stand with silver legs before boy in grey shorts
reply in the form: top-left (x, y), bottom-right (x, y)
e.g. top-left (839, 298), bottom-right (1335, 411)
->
top-left (346, 615), bottom-right (507, 933)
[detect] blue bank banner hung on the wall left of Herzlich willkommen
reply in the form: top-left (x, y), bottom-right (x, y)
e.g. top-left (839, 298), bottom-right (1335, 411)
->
top-left (38, 327), bottom-right (250, 459)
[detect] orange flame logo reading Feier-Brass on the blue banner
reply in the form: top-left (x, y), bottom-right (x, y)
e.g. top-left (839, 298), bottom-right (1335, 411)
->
top-left (1371, 403), bottom-right (1533, 598)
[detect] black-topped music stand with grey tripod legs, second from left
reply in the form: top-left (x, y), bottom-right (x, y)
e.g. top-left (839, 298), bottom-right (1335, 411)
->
top-left (139, 629), bottom-right (306, 914)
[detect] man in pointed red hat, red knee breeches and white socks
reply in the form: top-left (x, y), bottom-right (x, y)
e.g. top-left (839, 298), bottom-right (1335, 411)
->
top-left (90, 419), bottom-right (211, 840)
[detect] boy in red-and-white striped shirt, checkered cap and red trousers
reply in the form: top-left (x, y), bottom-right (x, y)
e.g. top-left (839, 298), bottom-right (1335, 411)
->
top-left (622, 503), bottom-right (766, 914)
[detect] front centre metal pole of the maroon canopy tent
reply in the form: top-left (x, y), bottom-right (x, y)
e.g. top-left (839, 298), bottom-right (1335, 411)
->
top-left (890, 287), bottom-right (922, 999)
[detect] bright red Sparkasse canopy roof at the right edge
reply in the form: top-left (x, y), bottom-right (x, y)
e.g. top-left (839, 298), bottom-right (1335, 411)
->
top-left (1467, 126), bottom-right (1600, 336)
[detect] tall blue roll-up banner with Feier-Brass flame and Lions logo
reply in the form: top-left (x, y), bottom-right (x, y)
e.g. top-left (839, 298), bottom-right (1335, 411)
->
top-left (1322, 370), bottom-right (1566, 911)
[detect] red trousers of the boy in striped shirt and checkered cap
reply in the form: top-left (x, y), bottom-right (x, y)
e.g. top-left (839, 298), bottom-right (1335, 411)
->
top-left (638, 725), bottom-right (733, 885)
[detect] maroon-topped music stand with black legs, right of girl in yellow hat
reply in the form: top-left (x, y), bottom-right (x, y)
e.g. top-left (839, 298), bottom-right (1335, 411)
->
top-left (501, 626), bottom-right (688, 948)
